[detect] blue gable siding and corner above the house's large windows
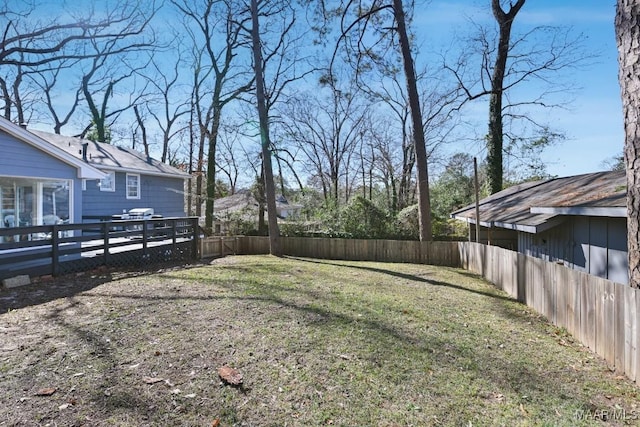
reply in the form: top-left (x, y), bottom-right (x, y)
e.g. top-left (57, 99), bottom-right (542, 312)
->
top-left (0, 131), bottom-right (83, 222)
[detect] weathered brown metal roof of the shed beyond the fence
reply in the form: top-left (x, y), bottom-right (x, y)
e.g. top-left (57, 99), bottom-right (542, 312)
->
top-left (451, 171), bottom-right (627, 233)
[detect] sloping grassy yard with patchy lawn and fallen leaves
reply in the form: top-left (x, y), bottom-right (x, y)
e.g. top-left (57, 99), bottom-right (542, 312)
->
top-left (0, 256), bottom-right (640, 426)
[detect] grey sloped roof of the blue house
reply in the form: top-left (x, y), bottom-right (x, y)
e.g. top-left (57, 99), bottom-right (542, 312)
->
top-left (29, 130), bottom-right (189, 179)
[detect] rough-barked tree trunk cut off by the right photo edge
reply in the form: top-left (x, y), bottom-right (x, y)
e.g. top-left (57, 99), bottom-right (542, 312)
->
top-left (616, 0), bottom-right (640, 288)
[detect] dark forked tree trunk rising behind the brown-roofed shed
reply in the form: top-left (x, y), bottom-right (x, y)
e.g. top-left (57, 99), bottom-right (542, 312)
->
top-left (487, 0), bottom-right (525, 194)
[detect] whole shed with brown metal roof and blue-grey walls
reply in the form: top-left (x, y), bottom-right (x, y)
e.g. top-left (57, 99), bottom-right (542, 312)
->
top-left (451, 171), bottom-right (629, 284)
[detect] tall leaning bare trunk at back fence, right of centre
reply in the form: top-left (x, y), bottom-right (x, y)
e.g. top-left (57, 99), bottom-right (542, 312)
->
top-left (393, 0), bottom-right (432, 241)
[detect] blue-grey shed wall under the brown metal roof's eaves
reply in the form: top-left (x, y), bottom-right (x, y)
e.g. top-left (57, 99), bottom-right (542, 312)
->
top-left (518, 217), bottom-right (629, 284)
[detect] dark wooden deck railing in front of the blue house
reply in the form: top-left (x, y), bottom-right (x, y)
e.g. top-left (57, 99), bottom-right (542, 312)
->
top-left (0, 217), bottom-right (199, 279)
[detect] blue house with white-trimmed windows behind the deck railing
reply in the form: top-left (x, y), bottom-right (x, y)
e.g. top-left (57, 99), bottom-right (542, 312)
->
top-left (0, 118), bottom-right (189, 237)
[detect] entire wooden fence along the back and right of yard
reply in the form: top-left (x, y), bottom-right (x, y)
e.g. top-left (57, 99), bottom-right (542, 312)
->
top-left (201, 236), bottom-right (640, 383)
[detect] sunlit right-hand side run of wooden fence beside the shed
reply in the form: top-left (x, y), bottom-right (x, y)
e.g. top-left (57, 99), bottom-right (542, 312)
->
top-left (459, 242), bottom-right (640, 383)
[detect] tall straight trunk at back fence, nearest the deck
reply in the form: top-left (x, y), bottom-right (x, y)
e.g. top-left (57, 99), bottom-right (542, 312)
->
top-left (251, 0), bottom-right (282, 256)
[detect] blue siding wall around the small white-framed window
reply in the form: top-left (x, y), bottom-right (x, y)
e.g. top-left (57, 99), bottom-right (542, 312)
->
top-left (83, 172), bottom-right (185, 217)
